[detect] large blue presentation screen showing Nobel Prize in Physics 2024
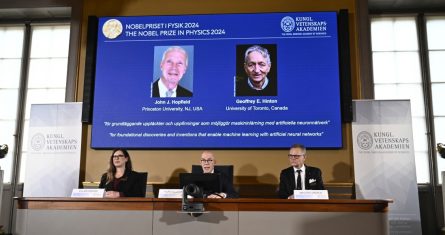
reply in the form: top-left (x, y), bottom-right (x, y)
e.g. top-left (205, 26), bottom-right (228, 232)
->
top-left (91, 12), bottom-right (342, 149)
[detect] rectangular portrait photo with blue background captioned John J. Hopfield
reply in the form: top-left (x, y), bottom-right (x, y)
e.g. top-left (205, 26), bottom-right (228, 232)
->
top-left (151, 46), bottom-right (193, 98)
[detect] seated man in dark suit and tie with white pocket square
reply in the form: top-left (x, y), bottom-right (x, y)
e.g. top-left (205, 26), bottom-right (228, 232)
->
top-left (278, 144), bottom-right (324, 198)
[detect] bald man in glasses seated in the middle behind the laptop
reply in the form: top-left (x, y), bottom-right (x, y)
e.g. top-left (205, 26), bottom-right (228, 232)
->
top-left (201, 151), bottom-right (238, 198)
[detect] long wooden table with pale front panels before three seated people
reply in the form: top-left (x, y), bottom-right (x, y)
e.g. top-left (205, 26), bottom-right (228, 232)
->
top-left (15, 198), bottom-right (390, 235)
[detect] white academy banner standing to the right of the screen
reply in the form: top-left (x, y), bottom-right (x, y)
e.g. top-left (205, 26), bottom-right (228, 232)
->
top-left (352, 100), bottom-right (422, 235)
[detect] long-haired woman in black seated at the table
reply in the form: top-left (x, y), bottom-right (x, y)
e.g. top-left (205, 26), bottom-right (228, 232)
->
top-left (99, 149), bottom-right (147, 198)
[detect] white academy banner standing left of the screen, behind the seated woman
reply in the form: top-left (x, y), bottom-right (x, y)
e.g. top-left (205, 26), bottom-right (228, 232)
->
top-left (23, 103), bottom-right (82, 197)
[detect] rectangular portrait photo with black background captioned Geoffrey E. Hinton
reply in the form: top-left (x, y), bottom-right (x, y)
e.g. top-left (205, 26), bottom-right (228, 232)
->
top-left (235, 44), bottom-right (277, 96)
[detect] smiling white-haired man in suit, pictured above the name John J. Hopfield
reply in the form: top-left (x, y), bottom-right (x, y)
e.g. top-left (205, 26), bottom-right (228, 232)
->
top-left (151, 46), bottom-right (193, 97)
